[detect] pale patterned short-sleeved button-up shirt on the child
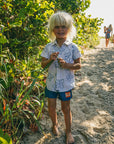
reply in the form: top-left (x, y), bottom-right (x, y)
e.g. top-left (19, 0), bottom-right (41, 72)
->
top-left (41, 41), bottom-right (81, 92)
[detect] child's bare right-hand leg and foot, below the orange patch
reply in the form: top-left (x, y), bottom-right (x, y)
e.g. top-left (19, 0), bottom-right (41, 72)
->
top-left (61, 100), bottom-right (74, 144)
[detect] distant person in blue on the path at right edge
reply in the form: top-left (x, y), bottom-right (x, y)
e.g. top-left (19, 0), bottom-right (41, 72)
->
top-left (104, 24), bottom-right (113, 47)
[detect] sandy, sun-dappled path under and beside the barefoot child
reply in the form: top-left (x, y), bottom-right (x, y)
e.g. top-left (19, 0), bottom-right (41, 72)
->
top-left (20, 39), bottom-right (114, 144)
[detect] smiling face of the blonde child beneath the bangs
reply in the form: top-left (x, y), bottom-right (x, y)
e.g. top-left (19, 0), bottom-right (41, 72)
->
top-left (53, 25), bottom-right (68, 40)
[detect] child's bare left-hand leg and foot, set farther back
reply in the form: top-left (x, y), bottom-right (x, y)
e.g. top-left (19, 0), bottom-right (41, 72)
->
top-left (48, 98), bottom-right (59, 135)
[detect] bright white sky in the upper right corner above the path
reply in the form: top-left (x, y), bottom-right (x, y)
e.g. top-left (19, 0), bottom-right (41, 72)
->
top-left (85, 0), bottom-right (114, 36)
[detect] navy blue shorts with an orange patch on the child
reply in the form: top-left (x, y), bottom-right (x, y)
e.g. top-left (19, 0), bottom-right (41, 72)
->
top-left (45, 88), bottom-right (72, 101)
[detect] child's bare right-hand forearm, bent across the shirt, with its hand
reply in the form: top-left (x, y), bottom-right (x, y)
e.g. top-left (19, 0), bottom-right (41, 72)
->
top-left (59, 58), bottom-right (81, 70)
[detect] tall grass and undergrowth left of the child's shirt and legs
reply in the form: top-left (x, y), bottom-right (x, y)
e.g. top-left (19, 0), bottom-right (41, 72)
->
top-left (0, 51), bottom-right (46, 143)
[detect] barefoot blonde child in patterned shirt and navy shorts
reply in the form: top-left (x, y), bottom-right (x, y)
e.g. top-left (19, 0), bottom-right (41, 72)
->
top-left (41, 11), bottom-right (81, 144)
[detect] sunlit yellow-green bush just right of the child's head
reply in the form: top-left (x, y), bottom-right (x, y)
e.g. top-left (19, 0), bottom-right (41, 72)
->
top-left (73, 13), bottom-right (103, 48)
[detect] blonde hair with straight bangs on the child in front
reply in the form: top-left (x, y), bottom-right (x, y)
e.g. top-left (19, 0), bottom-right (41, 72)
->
top-left (48, 11), bottom-right (76, 41)
